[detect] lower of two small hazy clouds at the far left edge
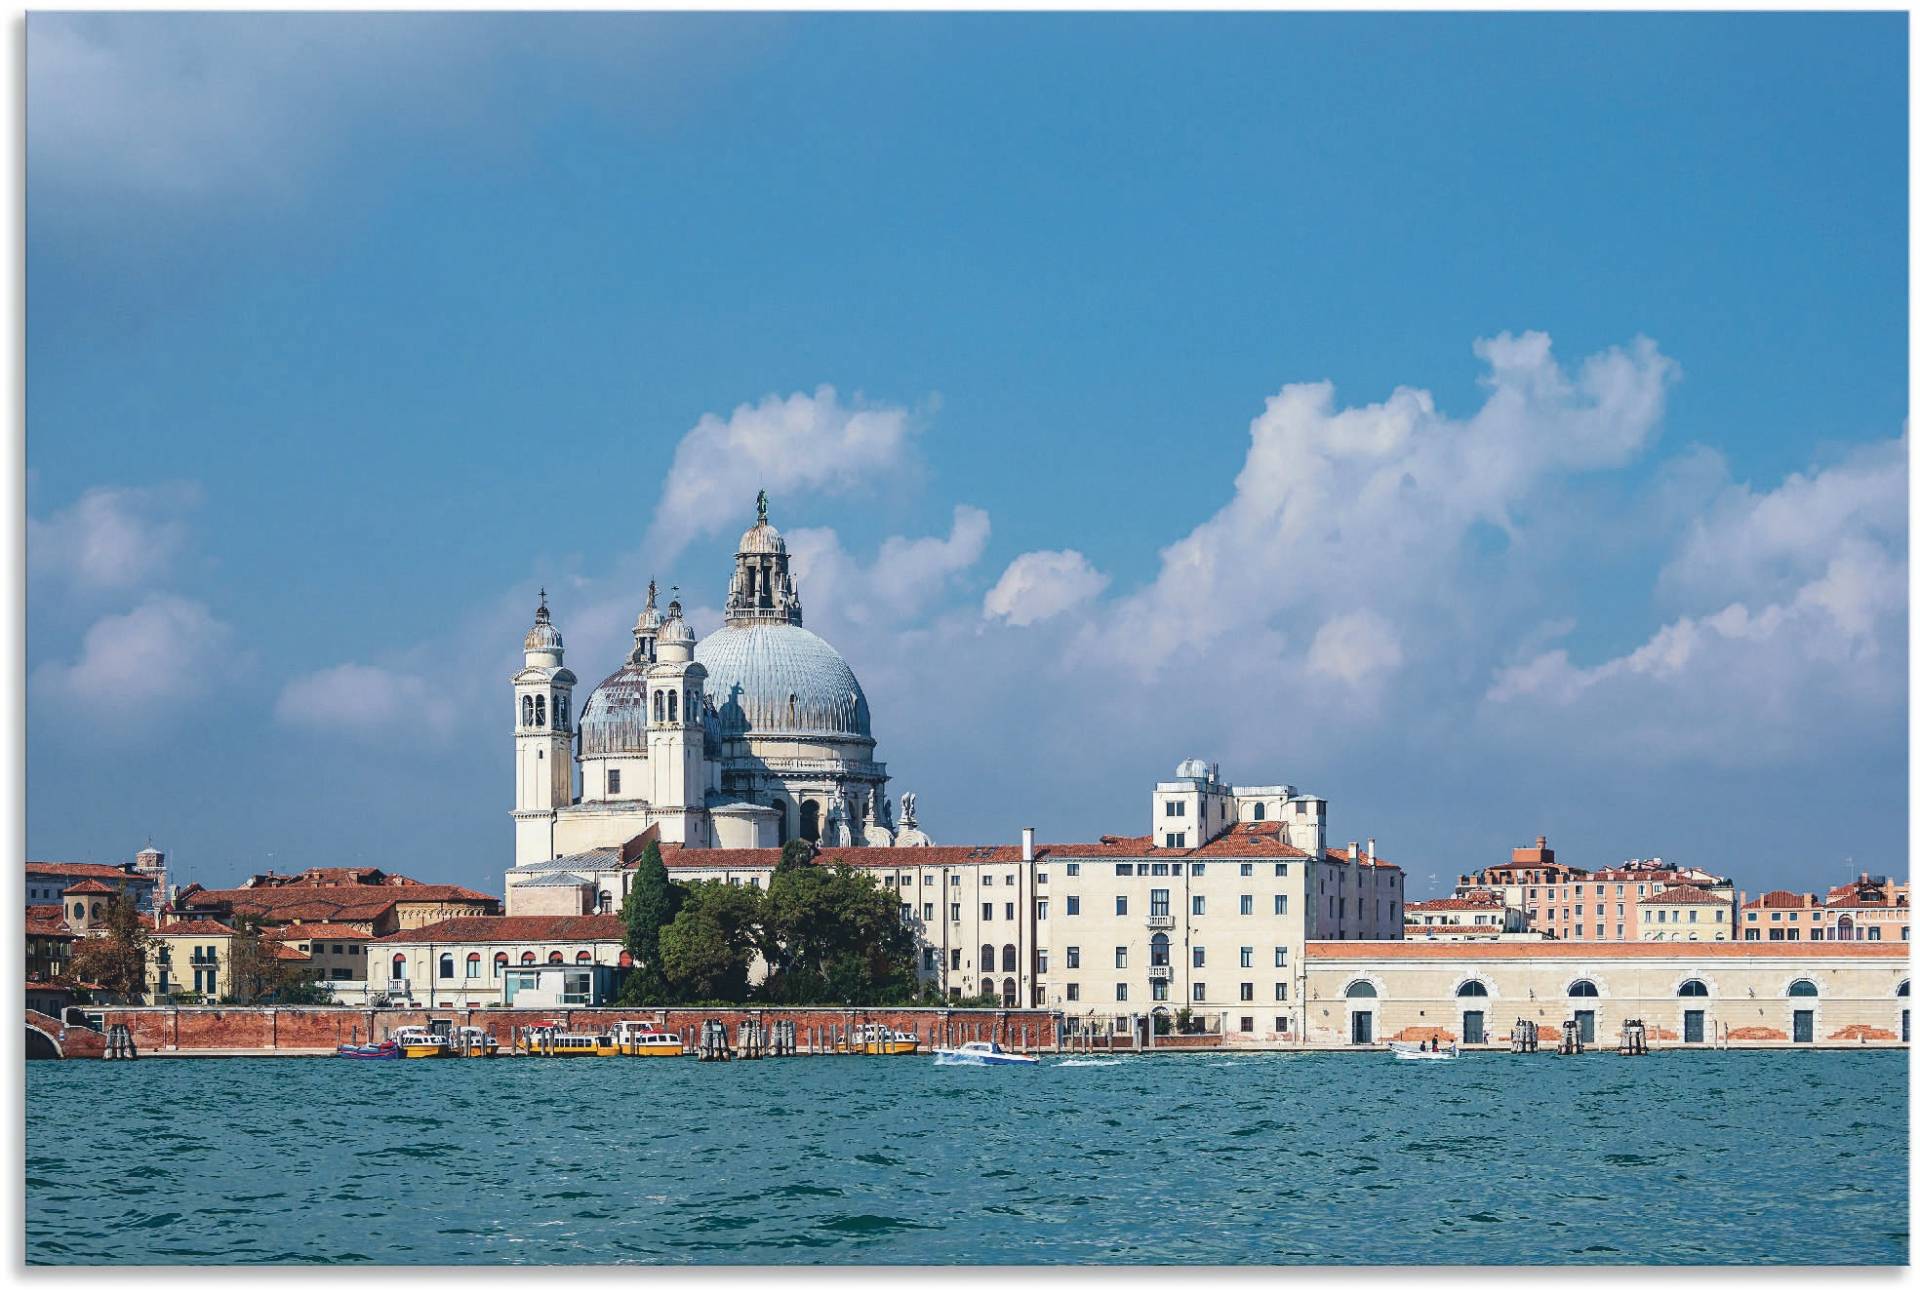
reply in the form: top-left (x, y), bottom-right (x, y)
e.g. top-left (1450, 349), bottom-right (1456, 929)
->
top-left (33, 593), bottom-right (232, 720)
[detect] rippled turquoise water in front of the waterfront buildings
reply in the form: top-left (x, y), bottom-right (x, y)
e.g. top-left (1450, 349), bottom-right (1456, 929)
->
top-left (27, 1052), bottom-right (1907, 1263)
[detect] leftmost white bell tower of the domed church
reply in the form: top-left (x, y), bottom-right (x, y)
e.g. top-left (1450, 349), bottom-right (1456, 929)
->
top-left (513, 589), bottom-right (576, 866)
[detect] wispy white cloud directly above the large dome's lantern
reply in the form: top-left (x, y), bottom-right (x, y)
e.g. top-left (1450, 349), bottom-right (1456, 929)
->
top-left (647, 386), bottom-right (914, 563)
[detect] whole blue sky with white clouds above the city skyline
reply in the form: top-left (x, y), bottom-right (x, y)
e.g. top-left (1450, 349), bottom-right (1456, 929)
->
top-left (27, 13), bottom-right (1907, 893)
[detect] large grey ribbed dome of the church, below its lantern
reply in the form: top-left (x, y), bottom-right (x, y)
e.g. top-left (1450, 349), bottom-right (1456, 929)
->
top-left (693, 624), bottom-right (874, 741)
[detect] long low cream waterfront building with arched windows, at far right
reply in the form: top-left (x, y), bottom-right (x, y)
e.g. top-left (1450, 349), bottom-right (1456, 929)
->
top-left (1304, 941), bottom-right (1908, 1048)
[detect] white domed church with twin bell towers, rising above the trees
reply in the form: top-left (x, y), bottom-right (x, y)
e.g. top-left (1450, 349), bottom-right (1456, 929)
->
top-left (507, 491), bottom-right (929, 875)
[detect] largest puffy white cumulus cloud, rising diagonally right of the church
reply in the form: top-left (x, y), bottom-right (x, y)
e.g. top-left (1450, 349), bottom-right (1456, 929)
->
top-left (1104, 332), bottom-right (1678, 670)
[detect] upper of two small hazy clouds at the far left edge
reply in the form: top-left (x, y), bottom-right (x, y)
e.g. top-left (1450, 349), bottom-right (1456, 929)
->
top-left (27, 484), bottom-right (200, 591)
